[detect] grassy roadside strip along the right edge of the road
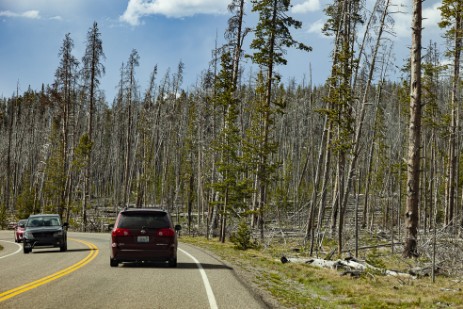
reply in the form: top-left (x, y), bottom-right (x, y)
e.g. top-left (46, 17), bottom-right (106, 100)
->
top-left (180, 236), bottom-right (463, 308)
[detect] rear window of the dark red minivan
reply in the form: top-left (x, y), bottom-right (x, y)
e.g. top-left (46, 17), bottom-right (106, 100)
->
top-left (118, 212), bottom-right (170, 229)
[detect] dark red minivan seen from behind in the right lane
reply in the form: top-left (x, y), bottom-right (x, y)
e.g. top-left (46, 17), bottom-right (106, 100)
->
top-left (110, 208), bottom-right (181, 267)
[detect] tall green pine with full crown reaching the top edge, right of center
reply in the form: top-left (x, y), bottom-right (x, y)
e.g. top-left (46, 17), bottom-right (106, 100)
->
top-left (249, 0), bottom-right (311, 240)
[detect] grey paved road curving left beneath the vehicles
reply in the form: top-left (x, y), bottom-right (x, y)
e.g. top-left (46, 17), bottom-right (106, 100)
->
top-left (0, 231), bottom-right (265, 309)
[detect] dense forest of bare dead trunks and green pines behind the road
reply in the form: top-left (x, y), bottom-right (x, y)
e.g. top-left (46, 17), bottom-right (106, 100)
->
top-left (0, 0), bottom-right (463, 266)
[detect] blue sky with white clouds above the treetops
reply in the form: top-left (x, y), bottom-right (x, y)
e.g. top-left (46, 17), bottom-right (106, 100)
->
top-left (0, 0), bottom-right (445, 103)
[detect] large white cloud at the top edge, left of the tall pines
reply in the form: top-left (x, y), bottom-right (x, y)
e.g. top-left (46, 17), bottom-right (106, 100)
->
top-left (120, 0), bottom-right (230, 26)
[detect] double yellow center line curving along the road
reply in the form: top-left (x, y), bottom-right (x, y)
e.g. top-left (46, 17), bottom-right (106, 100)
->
top-left (0, 239), bottom-right (98, 302)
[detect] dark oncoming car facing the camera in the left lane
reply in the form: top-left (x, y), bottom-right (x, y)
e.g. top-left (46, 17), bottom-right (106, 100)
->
top-left (23, 214), bottom-right (68, 253)
